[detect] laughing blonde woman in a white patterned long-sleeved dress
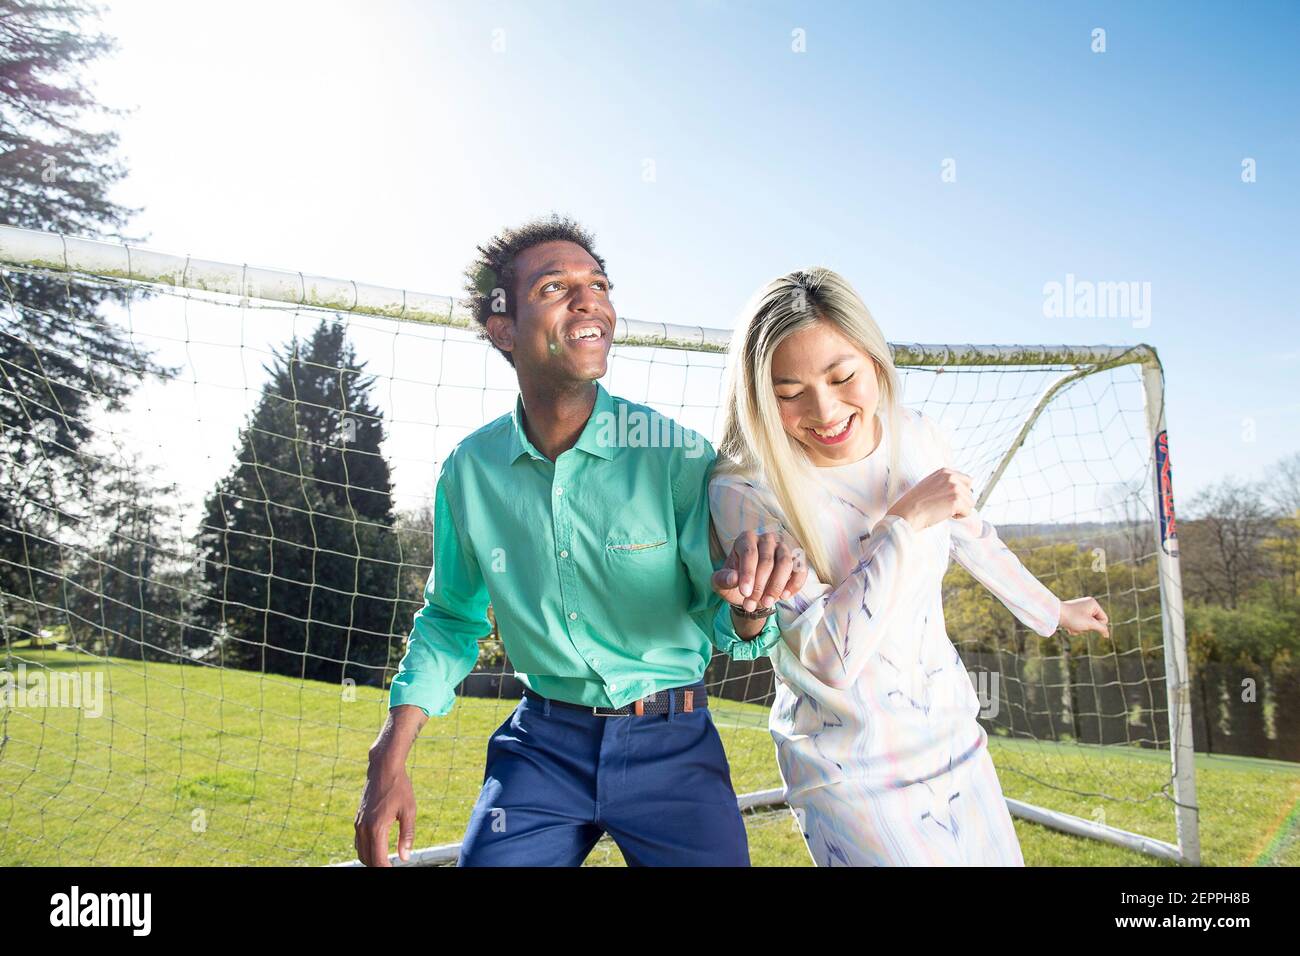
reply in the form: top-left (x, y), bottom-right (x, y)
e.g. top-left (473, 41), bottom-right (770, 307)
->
top-left (710, 269), bottom-right (1108, 866)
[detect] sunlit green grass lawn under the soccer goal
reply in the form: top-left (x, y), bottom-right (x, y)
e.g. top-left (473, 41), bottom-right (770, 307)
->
top-left (0, 646), bottom-right (1300, 866)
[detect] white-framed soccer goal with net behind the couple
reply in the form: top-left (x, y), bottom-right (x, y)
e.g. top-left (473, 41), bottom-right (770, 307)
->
top-left (0, 228), bottom-right (1200, 865)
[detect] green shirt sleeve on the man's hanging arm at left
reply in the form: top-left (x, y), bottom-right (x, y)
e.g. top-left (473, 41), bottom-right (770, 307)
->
top-left (389, 453), bottom-right (491, 717)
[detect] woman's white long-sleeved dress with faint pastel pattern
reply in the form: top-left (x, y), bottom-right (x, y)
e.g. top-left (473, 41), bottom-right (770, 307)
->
top-left (710, 408), bottom-right (1061, 866)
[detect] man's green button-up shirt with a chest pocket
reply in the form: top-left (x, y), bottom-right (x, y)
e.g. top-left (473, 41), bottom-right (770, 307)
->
top-left (389, 382), bottom-right (780, 715)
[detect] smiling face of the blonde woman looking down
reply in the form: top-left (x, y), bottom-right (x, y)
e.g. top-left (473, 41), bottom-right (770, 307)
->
top-left (772, 321), bottom-right (880, 467)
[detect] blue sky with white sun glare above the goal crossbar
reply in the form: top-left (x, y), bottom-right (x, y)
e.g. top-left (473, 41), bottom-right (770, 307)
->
top-left (94, 0), bottom-right (1300, 503)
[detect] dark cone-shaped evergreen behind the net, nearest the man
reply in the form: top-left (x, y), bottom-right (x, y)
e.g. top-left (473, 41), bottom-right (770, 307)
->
top-left (198, 323), bottom-right (402, 684)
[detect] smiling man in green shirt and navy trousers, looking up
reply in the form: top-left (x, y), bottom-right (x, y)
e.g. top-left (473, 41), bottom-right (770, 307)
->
top-left (355, 217), bottom-right (806, 866)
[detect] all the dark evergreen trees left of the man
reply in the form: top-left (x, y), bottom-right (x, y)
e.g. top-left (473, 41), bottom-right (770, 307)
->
top-left (0, 0), bottom-right (430, 683)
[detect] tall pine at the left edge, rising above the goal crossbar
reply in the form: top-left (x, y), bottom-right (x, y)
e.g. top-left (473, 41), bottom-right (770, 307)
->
top-left (0, 0), bottom-right (172, 628)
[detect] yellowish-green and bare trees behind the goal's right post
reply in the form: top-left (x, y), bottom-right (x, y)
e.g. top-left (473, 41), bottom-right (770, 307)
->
top-left (925, 463), bottom-right (1300, 761)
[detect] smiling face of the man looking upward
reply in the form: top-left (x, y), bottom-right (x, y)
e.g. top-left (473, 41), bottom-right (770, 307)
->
top-left (488, 241), bottom-right (618, 385)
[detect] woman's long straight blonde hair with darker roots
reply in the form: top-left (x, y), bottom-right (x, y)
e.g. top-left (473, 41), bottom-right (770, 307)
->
top-left (715, 267), bottom-right (901, 585)
